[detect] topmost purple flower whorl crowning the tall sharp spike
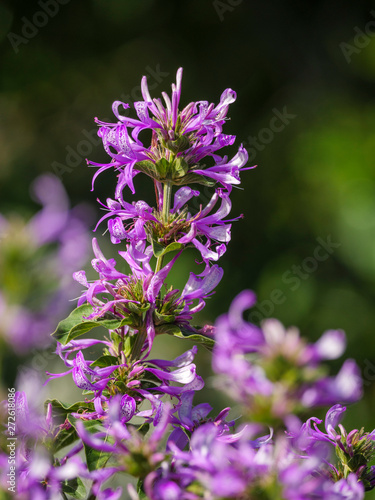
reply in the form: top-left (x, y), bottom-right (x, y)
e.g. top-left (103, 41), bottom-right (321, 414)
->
top-left (88, 68), bottom-right (253, 198)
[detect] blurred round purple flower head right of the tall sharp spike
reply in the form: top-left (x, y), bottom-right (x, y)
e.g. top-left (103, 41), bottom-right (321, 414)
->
top-left (213, 291), bottom-right (362, 424)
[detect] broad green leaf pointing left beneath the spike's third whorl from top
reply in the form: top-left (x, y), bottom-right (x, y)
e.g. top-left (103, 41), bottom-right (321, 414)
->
top-left (52, 304), bottom-right (134, 345)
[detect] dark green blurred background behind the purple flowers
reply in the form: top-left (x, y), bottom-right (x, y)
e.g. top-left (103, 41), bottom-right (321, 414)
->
top-left (0, 0), bottom-right (375, 492)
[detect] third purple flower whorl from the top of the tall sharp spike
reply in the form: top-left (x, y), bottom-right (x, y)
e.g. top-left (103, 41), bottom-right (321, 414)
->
top-left (74, 239), bottom-right (223, 356)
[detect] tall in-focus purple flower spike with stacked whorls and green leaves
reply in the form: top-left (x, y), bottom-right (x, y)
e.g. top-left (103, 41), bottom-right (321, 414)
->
top-left (43, 69), bottom-right (247, 436)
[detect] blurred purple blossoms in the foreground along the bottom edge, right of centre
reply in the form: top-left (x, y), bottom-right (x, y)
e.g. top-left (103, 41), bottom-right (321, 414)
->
top-left (159, 423), bottom-right (364, 500)
